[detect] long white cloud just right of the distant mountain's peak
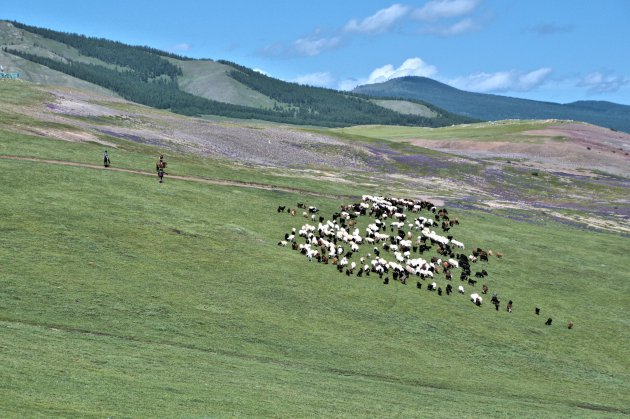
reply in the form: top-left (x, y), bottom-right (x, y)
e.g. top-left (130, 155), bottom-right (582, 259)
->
top-left (448, 67), bottom-right (552, 93)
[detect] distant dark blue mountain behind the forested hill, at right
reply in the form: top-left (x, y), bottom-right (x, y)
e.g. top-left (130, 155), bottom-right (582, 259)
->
top-left (353, 77), bottom-right (630, 132)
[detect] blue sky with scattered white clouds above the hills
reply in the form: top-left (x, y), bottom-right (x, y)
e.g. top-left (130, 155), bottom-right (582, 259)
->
top-left (0, 0), bottom-right (630, 105)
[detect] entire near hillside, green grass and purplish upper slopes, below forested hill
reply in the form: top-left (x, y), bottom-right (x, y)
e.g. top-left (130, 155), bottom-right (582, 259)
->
top-left (0, 80), bottom-right (630, 418)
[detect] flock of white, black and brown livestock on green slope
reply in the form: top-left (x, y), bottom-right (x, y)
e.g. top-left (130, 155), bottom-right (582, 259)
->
top-left (278, 195), bottom-right (572, 328)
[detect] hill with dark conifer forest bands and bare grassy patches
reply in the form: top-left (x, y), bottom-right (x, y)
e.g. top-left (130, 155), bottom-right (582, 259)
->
top-left (0, 21), bottom-right (472, 127)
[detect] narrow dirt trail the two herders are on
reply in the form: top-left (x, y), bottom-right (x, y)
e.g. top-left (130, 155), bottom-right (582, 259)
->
top-left (0, 155), bottom-right (360, 200)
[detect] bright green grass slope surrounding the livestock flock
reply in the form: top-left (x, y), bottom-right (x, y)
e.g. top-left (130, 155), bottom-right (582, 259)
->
top-left (0, 124), bottom-right (630, 418)
